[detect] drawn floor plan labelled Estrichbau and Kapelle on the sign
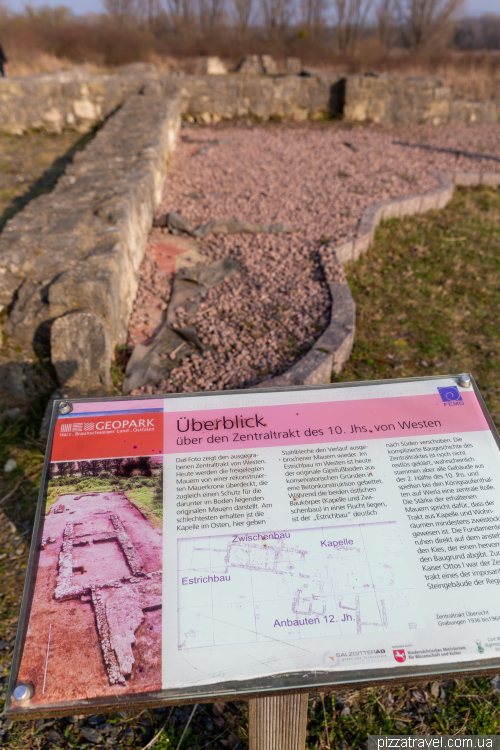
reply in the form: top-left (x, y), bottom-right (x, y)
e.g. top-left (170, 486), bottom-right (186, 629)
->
top-left (177, 523), bottom-right (422, 649)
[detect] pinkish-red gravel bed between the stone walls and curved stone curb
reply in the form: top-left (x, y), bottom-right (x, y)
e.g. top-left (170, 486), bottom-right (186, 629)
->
top-left (127, 124), bottom-right (500, 393)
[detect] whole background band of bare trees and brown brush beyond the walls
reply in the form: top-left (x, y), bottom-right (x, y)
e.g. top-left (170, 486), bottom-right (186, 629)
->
top-left (0, 0), bottom-right (500, 75)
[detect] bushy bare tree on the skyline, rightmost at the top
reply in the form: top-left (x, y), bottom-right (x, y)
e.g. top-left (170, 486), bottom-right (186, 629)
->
top-left (396, 0), bottom-right (464, 50)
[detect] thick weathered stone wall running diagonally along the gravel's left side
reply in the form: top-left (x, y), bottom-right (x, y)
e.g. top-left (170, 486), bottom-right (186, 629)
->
top-left (0, 93), bottom-right (181, 406)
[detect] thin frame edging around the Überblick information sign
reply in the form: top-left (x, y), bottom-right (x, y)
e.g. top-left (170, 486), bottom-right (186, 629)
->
top-left (5, 375), bottom-right (500, 719)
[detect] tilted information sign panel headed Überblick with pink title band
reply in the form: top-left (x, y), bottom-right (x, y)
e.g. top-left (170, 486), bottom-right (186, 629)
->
top-left (7, 377), bottom-right (500, 715)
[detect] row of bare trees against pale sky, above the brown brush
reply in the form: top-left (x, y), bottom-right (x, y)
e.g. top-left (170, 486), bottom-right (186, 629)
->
top-left (103, 0), bottom-right (500, 52)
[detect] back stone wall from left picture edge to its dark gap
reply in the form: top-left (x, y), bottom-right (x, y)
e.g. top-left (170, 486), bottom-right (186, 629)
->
top-left (0, 65), bottom-right (344, 134)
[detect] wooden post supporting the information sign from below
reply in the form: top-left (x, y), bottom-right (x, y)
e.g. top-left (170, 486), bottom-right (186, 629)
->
top-left (248, 693), bottom-right (309, 750)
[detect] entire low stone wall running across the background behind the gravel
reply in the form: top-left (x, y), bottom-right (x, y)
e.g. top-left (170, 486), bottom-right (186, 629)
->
top-left (0, 64), bottom-right (500, 133)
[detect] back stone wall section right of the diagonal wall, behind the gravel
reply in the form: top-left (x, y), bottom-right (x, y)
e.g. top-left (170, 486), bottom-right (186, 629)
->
top-left (180, 72), bottom-right (500, 125)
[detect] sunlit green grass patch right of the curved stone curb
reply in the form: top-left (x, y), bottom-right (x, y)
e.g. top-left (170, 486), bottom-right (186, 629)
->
top-left (337, 188), bottom-right (500, 432)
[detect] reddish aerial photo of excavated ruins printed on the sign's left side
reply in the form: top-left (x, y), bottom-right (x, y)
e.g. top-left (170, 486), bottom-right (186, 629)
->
top-left (18, 456), bottom-right (163, 704)
